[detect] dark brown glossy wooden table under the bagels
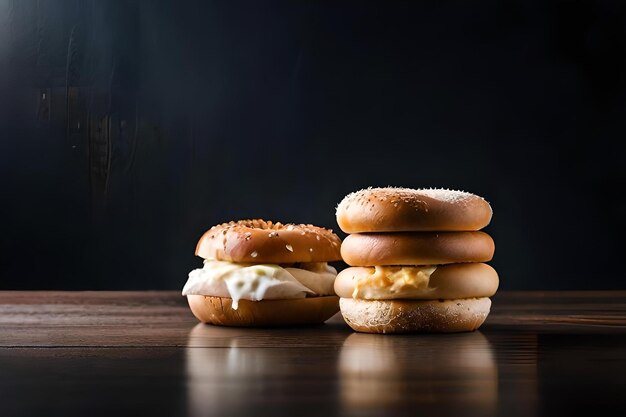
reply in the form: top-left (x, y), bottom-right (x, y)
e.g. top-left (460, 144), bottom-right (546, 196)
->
top-left (0, 292), bottom-right (626, 417)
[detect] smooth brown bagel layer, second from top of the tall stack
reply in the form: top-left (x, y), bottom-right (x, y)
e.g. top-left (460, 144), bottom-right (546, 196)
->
top-left (341, 232), bottom-right (495, 266)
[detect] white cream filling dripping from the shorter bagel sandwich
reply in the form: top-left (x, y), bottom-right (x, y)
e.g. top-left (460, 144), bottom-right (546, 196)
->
top-left (183, 259), bottom-right (337, 310)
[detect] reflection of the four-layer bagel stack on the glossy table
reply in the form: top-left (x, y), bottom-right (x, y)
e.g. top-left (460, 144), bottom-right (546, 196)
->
top-left (339, 332), bottom-right (498, 415)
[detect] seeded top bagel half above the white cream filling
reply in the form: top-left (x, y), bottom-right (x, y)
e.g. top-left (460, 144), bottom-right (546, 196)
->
top-left (196, 220), bottom-right (341, 263)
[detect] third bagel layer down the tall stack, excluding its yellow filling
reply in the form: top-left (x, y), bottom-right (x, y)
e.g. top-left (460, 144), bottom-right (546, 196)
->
top-left (335, 263), bottom-right (500, 300)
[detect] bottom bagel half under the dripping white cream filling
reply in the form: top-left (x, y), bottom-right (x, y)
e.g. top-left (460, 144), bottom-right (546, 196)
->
top-left (187, 295), bottom-right (339, 327)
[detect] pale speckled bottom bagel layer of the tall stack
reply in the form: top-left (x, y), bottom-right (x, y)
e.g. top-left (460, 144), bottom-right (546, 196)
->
top-left (339, 297), bottom-right (491, 333)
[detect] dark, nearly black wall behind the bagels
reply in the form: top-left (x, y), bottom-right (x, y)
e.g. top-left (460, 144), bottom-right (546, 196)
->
top-left (0, 0), bottom-right (626, 289)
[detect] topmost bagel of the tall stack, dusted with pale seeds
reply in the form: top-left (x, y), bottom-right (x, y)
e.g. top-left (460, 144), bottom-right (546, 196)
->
top-left (337, 187), bottom-right (492, 233)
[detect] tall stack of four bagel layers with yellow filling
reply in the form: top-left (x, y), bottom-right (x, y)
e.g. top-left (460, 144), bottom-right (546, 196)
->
top-left (335, 187), bottom-right (499, 333)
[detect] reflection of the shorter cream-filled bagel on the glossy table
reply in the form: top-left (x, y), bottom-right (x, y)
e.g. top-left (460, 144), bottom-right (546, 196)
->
top-left (185, 324), bottom-right (350, 416)
